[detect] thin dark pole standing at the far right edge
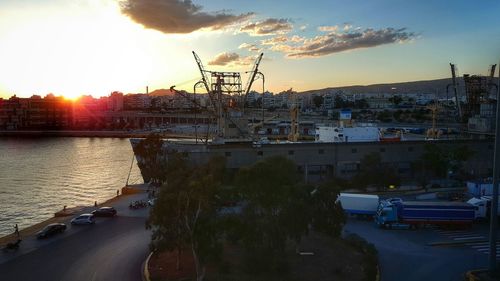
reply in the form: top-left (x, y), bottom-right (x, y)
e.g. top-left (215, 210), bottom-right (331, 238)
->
top-left (489, 60), bottom-right (500, 275)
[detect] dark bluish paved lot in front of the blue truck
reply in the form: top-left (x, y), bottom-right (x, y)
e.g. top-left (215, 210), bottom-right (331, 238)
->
top-left (344, 219), bottom-right (488, 281)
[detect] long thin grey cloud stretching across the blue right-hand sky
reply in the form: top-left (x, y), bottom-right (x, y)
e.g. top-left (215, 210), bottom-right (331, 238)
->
top-left (262, 26), bottom-right (416, 58)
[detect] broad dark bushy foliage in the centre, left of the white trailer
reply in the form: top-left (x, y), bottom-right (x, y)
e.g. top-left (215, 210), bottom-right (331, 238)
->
top-left (226, 157), bottom-right (345, 272)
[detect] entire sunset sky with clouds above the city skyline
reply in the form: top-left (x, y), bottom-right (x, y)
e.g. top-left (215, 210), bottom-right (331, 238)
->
top-left (0, 0), bottom-right (500, 98)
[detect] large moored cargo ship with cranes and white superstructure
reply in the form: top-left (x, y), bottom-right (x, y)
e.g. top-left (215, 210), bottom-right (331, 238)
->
top-left (130, 52), bottom-right (493, 182)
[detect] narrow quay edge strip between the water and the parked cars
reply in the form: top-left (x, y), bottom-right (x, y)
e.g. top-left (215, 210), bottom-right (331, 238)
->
top-left (0, 184), bottom-right (145, 246)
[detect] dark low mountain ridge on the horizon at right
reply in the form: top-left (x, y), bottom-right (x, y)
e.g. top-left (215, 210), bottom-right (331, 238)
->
top-left (301, 77), bottom-right (498, 96)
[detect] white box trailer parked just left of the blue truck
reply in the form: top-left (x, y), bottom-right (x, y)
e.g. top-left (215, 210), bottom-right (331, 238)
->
top-left (337, 193), bottom-right (380, 216)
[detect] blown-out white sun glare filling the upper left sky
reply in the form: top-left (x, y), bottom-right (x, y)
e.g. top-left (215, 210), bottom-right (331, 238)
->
top-left (0, 1), bottom-right (159, 98)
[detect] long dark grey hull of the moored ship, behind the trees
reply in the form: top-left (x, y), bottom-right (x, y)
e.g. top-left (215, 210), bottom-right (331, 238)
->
top-left (131, 139), bottom-right (494, 182)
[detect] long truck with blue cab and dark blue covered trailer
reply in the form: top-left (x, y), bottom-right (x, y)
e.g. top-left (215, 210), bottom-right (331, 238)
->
top-left (375, 201), bottom-right (476, 228)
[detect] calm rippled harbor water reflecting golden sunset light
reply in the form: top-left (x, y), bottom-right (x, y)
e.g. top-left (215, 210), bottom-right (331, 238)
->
top-left (0, 138), bottom-right (142, 236)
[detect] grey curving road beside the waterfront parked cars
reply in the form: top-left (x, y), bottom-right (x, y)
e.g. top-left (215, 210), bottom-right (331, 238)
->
top-left (0, 192), bottom-right (150, 281)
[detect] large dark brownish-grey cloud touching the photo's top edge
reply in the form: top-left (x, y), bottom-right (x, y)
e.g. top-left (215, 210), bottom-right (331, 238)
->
top-left (119, 0), bottom-right (253, 33)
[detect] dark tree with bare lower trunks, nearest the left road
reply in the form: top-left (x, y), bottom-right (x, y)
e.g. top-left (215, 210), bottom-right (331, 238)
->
top-left (147, 153), bottom-right (225, 281)
